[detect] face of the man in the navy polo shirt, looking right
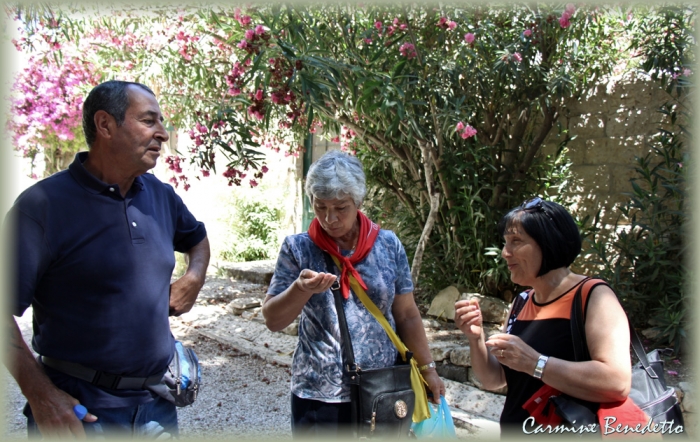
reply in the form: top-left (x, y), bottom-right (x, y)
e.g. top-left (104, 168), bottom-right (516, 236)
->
top-left (112, 86), bottom-right (170, 176)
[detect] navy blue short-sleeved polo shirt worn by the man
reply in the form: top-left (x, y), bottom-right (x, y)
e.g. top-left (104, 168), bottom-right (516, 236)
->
top-left (8, 152), bottom-right (206, 409)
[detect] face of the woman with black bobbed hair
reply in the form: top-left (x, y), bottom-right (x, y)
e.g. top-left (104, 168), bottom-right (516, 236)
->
top-left (501, 226), bottom-right (542, 286)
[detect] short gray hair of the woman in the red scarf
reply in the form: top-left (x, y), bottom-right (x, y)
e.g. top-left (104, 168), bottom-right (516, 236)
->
top-left (304, 150), bottom-right (367, 207)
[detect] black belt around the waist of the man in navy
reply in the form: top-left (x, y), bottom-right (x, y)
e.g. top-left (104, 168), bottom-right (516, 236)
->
top-left (39, 356), bottom-right (163, 390)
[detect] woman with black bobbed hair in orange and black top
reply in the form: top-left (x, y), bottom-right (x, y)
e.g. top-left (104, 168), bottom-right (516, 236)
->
top-left (455, 198), bottom-right (631, 436)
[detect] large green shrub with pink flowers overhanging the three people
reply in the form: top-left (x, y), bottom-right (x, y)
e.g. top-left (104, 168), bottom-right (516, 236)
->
top-left (6, 4), bottom-right (691, 295)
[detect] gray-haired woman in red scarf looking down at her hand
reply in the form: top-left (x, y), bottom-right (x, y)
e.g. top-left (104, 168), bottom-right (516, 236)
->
top-left (262, 151), bottom-right (445, 438)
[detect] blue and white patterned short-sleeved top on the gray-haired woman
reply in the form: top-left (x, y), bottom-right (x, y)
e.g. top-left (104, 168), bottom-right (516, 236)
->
top-left (267, 230), bottom-right (413, 402)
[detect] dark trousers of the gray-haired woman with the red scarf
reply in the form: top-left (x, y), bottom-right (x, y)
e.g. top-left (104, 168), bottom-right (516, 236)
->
top-left (292, 393), bottom-right (352, 439)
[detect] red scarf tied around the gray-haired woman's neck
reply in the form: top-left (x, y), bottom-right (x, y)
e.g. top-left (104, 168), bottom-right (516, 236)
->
top-left (309, 210), bottom-right (379, 299)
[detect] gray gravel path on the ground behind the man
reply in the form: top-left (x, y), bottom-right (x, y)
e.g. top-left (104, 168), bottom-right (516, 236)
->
top-left (2, 278), bottom-right (291, 440)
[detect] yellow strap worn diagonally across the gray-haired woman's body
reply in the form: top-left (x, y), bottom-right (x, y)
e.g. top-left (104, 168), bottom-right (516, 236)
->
top-left (331, 255), bottom-right (430, 422)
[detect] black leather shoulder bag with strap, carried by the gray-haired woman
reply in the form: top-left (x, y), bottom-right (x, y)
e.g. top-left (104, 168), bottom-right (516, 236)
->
top-left (324, 253), bottom-right (415, 439)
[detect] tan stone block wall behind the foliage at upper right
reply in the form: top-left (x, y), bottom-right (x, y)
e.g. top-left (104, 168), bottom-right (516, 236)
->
top-left (543, 75), bottom-right (680, 226)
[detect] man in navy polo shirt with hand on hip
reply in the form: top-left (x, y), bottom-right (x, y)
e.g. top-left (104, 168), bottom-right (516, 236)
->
top-left (6, 81), bottom-right (209, 438)
